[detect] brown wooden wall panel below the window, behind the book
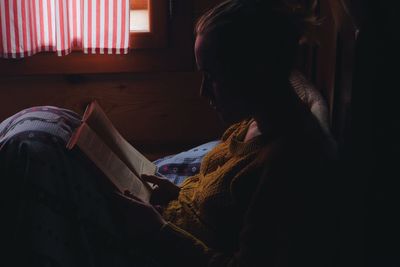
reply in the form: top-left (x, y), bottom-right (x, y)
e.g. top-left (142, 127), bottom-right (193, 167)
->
top-left (0, 72), bottom-right (222, 159)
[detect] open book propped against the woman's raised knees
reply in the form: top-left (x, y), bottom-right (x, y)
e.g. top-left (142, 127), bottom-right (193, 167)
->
top-left (67, 101), bottom-right (157, 202)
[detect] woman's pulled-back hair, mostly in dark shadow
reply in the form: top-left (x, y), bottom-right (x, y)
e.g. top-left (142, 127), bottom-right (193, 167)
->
top-left (195, 0), bottom-right (318, 80)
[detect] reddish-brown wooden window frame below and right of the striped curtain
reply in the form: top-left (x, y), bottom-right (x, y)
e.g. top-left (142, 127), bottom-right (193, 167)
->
top-left (0, 0), bottom-right (194, 76)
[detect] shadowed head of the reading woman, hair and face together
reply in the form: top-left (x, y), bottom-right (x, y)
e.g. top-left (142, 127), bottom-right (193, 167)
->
top-left (195, 0), bottom-right (318, 122)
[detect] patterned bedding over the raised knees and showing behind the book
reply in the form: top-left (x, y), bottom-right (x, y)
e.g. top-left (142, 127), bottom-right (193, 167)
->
top-left (0, 106), bottom-right (217, 267)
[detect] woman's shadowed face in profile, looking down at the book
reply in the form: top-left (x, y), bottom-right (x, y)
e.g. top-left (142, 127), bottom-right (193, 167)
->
top-left (194, 33), bottom-right (250, 123)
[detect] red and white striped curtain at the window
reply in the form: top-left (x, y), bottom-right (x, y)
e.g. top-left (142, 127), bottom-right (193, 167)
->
top-left (0, 0), bottom-right (129, 58)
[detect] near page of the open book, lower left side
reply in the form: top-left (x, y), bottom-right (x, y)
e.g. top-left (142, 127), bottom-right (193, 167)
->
top-left (76, 123), bottom-right (151, 202)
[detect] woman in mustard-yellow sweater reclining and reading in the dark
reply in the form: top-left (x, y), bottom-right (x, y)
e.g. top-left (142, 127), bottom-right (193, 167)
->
top-left (0, 0), bottom-right (335, 266)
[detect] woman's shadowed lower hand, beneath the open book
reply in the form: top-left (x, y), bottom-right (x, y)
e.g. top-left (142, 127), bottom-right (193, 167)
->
top-left (111, 192), bottom-right (167, 240)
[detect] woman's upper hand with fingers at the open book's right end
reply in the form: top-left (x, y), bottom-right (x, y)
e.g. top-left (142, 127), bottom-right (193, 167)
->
top-left (141, 174), bottom-right (181, 206)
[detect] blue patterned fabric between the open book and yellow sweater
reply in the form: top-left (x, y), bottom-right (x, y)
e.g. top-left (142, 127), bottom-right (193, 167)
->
top-left (153, 140), bottom-right (220, 185)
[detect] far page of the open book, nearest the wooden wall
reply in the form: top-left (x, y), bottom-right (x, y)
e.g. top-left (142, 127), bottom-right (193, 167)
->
top-left (83, 101), bottom-right (157, 177)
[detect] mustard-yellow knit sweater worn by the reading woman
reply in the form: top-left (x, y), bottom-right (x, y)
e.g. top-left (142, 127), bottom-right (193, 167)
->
top-left (153, 111), bottom-right (337, 267)
